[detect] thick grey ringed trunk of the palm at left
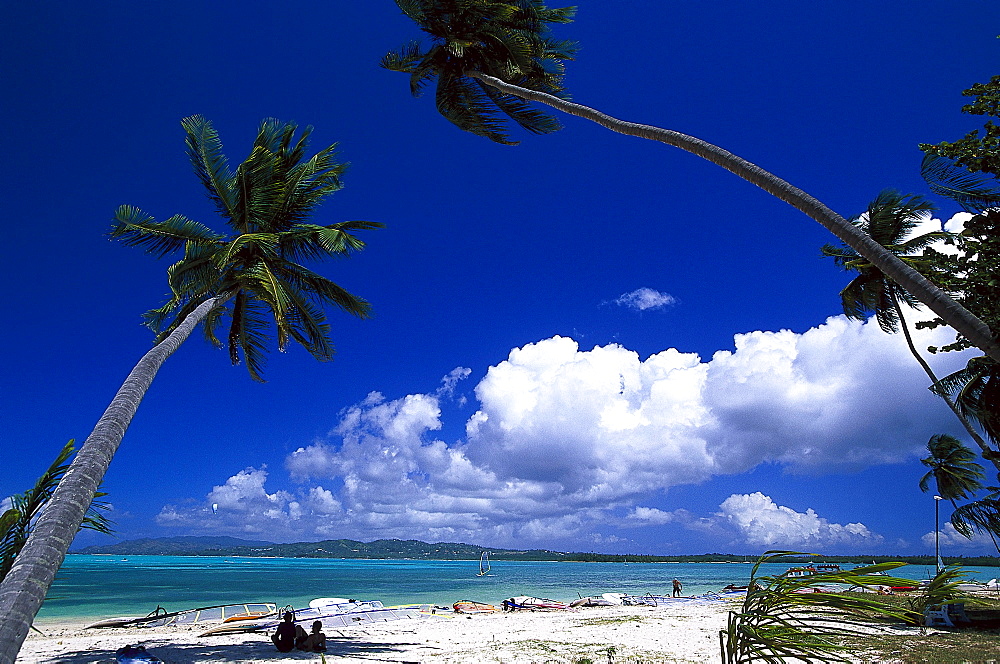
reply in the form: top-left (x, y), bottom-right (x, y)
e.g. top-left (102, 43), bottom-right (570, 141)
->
top-left (0, 295), bottom-right (228, 664)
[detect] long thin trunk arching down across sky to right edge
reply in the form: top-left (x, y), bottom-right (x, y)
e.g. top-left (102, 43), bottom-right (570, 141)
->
top-left (465, 71), bottom-right (1000, 362)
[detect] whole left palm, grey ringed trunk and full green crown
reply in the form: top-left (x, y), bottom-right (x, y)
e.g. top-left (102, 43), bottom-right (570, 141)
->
top-left (0, 116), bottom-right (381, 664)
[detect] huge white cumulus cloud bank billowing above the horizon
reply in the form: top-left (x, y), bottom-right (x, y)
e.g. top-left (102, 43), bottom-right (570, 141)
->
top-left (160, 304), bottom-right (964, 547)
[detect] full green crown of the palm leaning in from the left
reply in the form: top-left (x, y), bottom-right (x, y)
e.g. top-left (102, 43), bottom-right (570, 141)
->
top-left (111, 116), bottom-right (381, 380)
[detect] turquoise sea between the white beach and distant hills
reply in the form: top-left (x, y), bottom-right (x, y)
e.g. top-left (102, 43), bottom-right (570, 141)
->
top-left (38, 555), bottom-right (1000, 622)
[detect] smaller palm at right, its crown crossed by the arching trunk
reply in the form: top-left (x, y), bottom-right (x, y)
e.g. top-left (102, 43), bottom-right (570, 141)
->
top-left (820, 190), bottom-right (1000, 470)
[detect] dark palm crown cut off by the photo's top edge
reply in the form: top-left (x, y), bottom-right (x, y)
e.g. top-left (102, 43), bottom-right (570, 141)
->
top-left (380, 0), bottom-right (578, 145)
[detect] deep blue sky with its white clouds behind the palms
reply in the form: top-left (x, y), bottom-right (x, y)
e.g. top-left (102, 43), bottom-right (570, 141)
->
top-left (0, 0), bottom-right (1000, 554)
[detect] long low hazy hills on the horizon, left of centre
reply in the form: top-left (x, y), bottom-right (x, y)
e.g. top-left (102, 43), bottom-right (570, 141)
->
top-left (73, 537), bottom-right (566, 560)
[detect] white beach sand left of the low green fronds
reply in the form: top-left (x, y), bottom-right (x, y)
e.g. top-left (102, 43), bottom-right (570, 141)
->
top-left (17, 600), bottom-right (737, 664)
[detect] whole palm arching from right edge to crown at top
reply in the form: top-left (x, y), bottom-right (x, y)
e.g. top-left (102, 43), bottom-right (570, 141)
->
top-left (381, 0), bottom-right (1000, 361)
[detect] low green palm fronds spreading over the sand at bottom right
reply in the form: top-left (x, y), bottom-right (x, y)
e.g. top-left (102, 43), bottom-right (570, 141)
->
top-left (719, 551), bottom-right (911, 664)
